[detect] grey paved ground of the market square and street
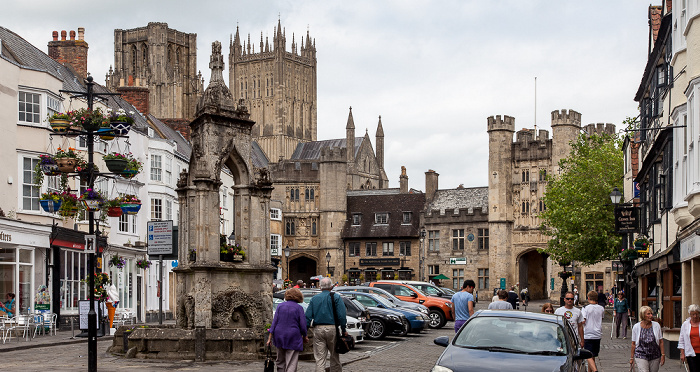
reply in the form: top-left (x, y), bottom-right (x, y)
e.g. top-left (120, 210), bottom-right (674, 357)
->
top-left (0, 301), bottom-right (681, 372)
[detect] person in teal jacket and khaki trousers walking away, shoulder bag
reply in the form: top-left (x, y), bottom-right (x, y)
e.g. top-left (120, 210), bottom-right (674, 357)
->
top-left (306, 277), bottom-right (348, 372)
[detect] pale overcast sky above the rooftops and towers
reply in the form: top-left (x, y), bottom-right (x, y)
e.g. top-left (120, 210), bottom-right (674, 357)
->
top-left (0, 0), bottom-right (649, 190)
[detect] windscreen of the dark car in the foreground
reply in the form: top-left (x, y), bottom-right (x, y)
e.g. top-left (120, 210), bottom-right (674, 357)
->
top-left (454, 316), bottom-right (567, 355)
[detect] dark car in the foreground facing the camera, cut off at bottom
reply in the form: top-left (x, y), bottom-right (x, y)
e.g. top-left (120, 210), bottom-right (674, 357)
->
top-left (432, 310), bottom-right (593, 372)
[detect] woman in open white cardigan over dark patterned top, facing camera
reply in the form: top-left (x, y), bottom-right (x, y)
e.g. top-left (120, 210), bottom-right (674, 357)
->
top-left (630, 306), bottom-right (666, 372)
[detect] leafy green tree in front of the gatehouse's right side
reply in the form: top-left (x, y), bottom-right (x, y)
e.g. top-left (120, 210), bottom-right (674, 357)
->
top-left (540, 134), bottom-right (624, 265)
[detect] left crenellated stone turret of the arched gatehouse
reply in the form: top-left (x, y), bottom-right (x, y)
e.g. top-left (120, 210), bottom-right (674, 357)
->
top-left (487, 115), bottom-right (515, 285)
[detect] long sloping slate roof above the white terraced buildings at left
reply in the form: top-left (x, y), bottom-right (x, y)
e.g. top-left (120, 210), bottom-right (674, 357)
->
top-left (0, 27), bottom-right (148, 132)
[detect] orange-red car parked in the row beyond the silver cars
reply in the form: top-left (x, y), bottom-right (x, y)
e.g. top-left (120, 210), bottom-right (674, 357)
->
top-left (370, 281), bottom-right (454, 328)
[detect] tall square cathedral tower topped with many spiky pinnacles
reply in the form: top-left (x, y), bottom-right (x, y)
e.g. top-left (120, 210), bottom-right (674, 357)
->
top-left (229, 21), bottom-right (317, 162)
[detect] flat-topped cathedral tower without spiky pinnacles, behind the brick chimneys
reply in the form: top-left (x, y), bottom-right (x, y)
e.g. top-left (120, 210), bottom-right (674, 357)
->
top-left (106, 22), bottom-right (203, 120)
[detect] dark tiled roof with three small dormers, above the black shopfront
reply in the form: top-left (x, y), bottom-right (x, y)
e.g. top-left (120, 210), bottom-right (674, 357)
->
top-left (341, 190), bottom-right (425, 239)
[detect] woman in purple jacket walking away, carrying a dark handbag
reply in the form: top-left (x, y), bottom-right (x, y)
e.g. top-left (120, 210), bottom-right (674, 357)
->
top-left (267, 288), bottom-right (309, 372)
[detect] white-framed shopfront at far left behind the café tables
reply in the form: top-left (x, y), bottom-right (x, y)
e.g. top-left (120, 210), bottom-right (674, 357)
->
top-left (0, 218), bottom-right (51, 313)
